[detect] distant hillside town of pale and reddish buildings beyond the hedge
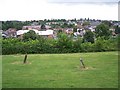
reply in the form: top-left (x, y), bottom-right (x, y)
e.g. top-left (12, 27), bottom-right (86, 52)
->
top-left (0, 19), bottom-right (120, 38)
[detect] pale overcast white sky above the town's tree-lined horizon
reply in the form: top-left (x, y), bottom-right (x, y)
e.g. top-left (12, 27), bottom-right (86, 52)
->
top-left (0, 0), bottom-right (118, 21)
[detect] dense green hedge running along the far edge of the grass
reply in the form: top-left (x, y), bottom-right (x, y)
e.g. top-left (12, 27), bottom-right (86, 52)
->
top-left (2, 35), bottom-right (117, 55)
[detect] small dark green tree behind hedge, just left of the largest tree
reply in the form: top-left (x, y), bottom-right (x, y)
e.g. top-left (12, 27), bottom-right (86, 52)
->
top-left (84, 30), bottom-right (94, 43)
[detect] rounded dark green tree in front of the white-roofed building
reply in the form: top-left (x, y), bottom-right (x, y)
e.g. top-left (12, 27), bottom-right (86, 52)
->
top-left (23, 30), bottom-right (38, 41)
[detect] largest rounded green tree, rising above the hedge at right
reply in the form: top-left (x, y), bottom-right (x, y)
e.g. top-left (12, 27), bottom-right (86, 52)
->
top-left (95, 23), bottom-right (111, 38)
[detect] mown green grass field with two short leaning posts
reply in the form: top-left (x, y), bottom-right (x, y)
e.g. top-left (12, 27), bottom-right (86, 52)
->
top-left (2, 52), bottom-right (118, 88)
